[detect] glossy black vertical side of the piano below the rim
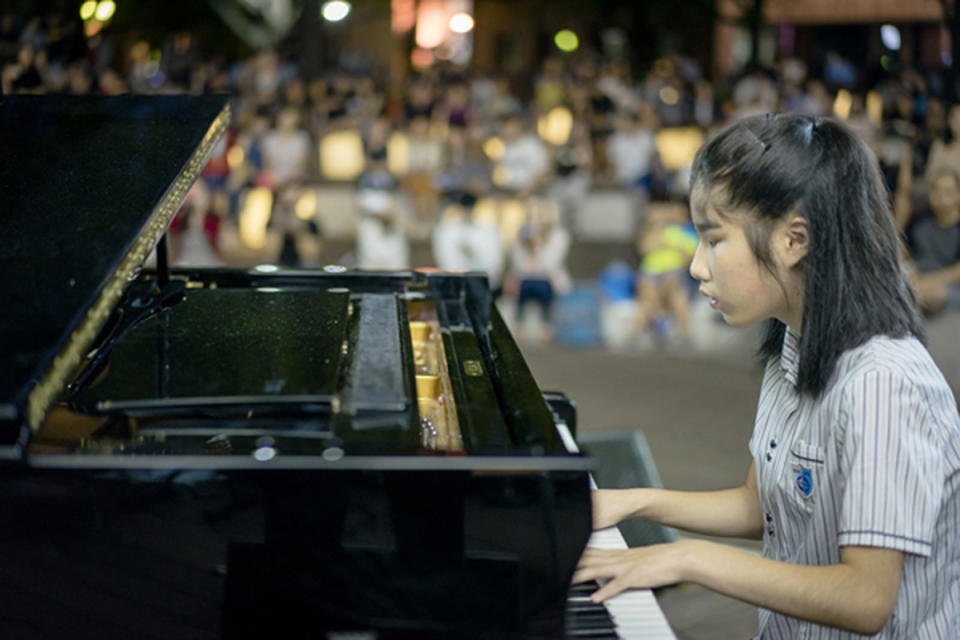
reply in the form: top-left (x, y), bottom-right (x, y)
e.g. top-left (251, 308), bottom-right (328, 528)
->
top-left (0, 468), bottom-right (590, 640)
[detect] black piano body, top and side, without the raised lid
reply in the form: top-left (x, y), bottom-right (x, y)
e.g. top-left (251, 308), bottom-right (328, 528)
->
top-left (7, 270), bottom-right (591, 640)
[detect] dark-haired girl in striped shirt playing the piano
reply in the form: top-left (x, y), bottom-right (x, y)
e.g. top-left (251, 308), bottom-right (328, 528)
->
top-left (575, 115), bottom-right (960, 638)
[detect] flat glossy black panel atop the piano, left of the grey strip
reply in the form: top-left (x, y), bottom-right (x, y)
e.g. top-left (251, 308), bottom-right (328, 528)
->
top-left (85, 289), bottom-right (349, 412)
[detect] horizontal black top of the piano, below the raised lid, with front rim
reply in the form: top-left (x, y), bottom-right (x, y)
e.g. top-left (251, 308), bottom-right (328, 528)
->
top-left (54, 270), bottom-right (586, 464)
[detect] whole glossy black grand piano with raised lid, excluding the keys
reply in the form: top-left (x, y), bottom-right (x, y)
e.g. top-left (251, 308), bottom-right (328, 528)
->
top-left (0, 96), bottom-right (615, 639)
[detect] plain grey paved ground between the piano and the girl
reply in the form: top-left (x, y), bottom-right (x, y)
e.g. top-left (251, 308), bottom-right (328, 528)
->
top-left (521, 308), bottom-right (960, 640)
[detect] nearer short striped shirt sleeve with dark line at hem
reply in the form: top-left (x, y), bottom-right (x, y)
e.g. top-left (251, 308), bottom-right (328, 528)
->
top-left (839, 371), bottom-right (945, 556)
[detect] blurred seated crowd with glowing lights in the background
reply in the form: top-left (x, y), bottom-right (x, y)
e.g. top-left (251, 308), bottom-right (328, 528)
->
top-left (7, 8), bottom-right (960, 346)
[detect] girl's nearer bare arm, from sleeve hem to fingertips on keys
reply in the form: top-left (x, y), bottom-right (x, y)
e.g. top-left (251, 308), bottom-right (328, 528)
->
top-left (574, 540), bottom-right (903, 635)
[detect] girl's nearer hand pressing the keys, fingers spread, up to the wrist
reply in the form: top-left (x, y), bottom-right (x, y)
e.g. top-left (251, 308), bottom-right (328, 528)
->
top-left (573, 540), bottom-right (696, 602)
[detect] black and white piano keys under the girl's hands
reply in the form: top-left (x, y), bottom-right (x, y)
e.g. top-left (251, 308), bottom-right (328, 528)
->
top-left (557, 422), bottom-right (676, 640)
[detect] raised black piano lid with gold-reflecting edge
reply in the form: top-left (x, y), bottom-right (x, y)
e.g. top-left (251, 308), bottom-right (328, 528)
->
top-left (0, 95), bottom-right (229, 458)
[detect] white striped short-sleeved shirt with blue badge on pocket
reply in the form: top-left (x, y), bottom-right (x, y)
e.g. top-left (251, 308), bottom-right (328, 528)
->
top-left (750, 330), bottom-right (960, 640)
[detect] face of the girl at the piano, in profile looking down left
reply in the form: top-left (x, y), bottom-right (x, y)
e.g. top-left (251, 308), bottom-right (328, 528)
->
top-left (690, 185), bottom-right (803, 330)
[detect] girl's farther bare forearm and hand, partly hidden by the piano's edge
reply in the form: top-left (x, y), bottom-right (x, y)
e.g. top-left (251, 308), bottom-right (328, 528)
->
top-left (593, 464), bottom-right (763, 539)
